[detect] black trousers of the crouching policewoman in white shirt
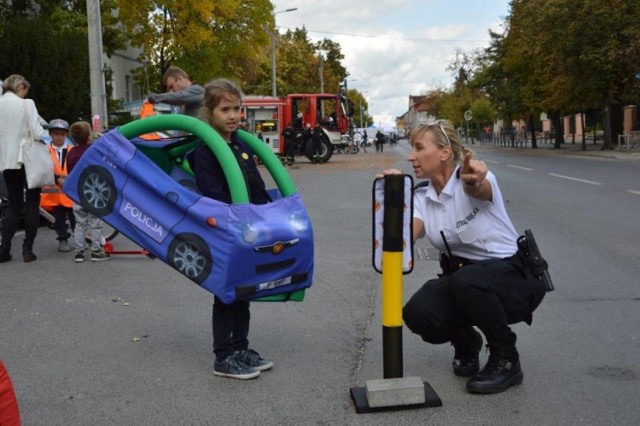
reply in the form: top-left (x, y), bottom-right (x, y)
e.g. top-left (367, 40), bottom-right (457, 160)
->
top-left (403, 259), bottom-right (546, 345)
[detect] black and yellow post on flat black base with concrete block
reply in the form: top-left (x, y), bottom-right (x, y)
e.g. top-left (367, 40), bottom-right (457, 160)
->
top-left (351, 175), bottom-right (442, 413)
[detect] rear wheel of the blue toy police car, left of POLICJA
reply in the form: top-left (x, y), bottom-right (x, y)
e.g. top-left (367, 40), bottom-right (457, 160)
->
top-left (78, 166), bottom-right (117, 217)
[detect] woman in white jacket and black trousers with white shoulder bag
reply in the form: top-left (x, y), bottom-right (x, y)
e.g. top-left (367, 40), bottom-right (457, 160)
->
top-left (0, 74), bottom-right (47, 263)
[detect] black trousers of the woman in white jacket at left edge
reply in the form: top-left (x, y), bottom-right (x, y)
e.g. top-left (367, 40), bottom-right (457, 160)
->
top-left (1, 167), bottom-right (40, 253)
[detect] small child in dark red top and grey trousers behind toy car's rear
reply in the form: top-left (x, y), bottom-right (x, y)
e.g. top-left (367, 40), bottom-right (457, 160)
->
top-left (67, 121), bottom-right (110, 263)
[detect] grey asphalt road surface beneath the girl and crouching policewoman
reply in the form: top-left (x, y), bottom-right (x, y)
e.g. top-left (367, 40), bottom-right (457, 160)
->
top-left (0, 141), bottom-right (640, 425)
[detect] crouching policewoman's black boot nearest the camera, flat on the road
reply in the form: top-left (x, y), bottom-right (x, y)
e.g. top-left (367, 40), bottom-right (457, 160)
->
top-left (467, 344), bottom-right (523, 393)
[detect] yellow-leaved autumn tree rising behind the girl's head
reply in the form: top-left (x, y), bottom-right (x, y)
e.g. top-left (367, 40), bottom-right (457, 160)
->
top-left (118, 0), bottom-right (274, 91)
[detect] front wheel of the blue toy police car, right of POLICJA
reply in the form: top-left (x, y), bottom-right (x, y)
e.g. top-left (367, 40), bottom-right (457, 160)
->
top-left (167, 234), bottom-right (213, 284)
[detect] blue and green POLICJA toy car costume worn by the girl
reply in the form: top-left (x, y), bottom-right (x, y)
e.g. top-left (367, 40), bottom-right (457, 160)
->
top-left (64, 115), bottom-right (313, 303)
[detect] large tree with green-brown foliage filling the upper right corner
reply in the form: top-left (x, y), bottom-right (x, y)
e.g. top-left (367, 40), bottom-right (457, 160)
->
top-left (464, 0), bottom-right (640, 145)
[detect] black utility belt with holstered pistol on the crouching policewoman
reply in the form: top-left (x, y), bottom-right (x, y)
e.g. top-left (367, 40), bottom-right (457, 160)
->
top-left (440, 229), bottom-right (554, 291)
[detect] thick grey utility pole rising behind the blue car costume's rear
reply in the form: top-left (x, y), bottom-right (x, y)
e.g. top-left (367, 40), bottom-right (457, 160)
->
top-left (87, 0), bottom-right (109, 132)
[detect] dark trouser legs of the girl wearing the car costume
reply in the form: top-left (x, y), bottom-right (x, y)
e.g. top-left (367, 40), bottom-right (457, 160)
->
top-left (211, 296), bottom-right (251, 361)
